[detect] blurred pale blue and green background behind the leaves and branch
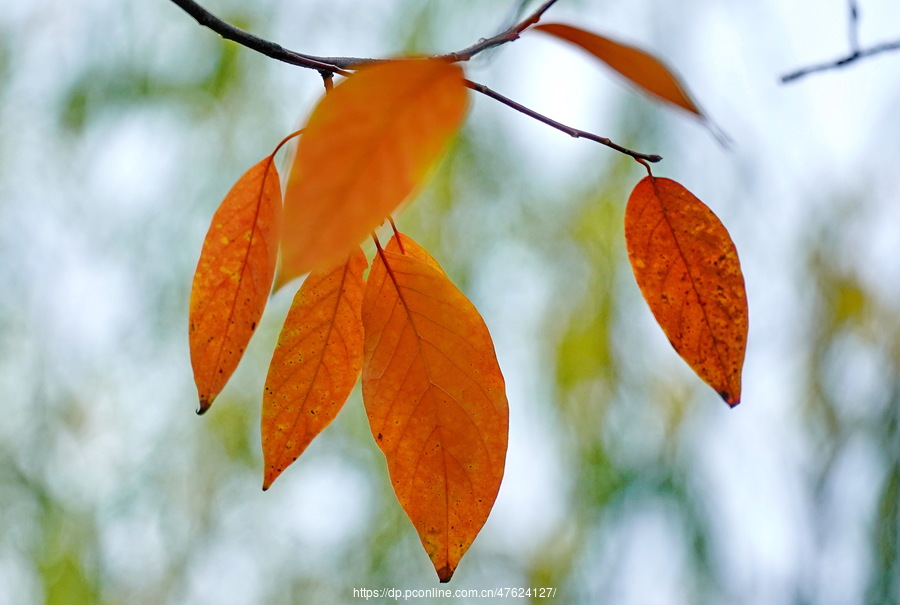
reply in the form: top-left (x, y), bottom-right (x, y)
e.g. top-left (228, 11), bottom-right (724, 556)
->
top-left (0, 0), bottom-right (900, 605)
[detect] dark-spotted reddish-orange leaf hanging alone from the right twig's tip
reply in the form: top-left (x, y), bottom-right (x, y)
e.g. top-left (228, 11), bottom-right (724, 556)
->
top-left (625, 176), bottom-right (748, 406)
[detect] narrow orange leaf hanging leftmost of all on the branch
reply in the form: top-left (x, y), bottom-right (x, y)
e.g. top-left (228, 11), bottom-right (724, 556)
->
top-left (189, 156), bottom-right (281, 414)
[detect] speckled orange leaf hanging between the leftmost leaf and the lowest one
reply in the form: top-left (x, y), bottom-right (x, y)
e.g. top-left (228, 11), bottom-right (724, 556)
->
top-left (262, 247), bottom-right (368, 490)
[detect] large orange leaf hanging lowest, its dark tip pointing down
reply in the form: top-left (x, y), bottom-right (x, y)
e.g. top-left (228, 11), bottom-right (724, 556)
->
top-left (362, 237), bottom-right (509, 582)
